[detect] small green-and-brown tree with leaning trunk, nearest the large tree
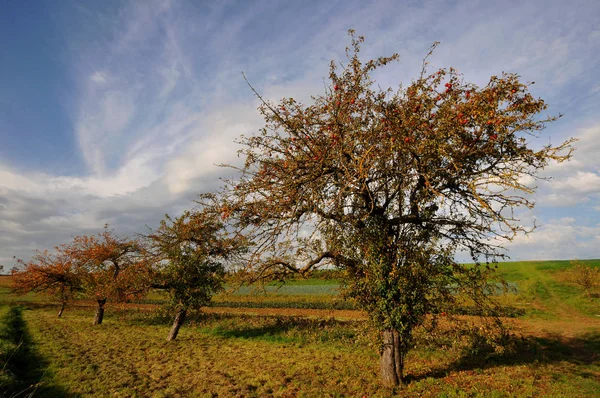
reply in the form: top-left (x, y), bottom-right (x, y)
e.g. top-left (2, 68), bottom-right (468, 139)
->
top-left (148, 208), bottom-right (245, 341)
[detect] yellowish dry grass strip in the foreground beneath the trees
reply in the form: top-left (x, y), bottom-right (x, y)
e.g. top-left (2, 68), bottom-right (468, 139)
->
top-left (11, 308), bottom-right (600, 397)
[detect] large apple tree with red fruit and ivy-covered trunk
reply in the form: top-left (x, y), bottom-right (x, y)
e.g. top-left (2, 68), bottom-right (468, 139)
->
top-left (221, 32), bottom-right (572, 385)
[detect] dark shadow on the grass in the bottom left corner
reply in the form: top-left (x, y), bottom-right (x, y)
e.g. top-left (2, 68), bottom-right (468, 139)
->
top-left (0, 307), bottom-right (78, 398)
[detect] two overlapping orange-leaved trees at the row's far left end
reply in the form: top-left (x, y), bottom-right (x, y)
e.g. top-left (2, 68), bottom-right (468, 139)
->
top-left (13, 228), bottom-right (152, 324)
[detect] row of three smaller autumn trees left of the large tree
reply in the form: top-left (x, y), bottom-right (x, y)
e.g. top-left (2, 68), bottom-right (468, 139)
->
top-left (12, 208), bottom-right (246, 341)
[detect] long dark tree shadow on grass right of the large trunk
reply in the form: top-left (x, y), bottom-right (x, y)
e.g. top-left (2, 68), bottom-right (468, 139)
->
top-left (409, 332), bottom-right (600, 381)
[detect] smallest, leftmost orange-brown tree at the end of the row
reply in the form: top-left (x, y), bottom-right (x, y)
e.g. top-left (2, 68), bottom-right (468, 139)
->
top-left (11, 252), bottom-right (83, 318)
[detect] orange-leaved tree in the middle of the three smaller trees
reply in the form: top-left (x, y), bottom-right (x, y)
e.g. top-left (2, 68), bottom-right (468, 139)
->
top-left (61, 229), bottom-right (151, 325)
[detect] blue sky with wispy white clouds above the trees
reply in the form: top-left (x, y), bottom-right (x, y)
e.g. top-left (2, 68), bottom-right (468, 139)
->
top-left (0, 0), bottom-right (600, 266)
